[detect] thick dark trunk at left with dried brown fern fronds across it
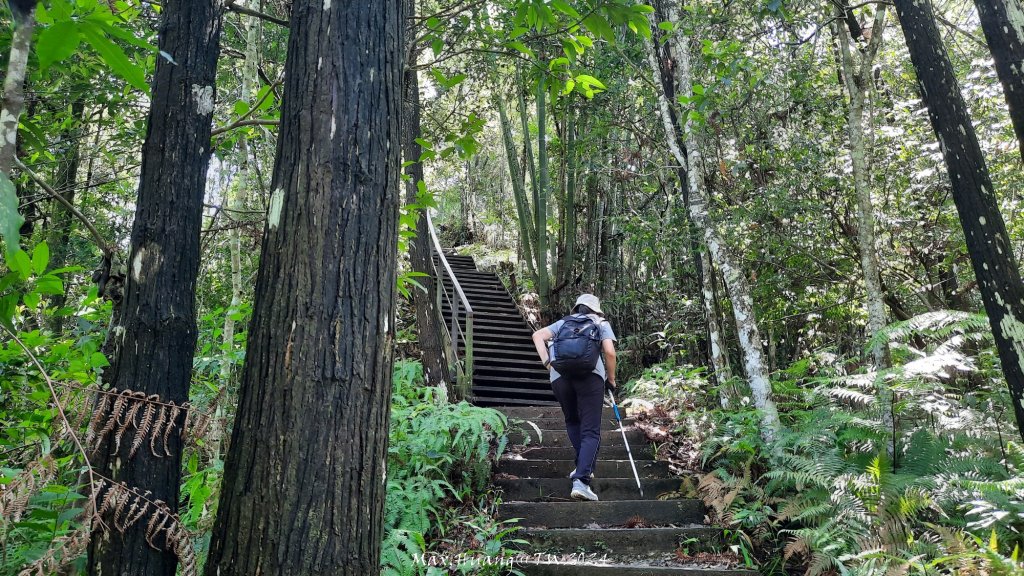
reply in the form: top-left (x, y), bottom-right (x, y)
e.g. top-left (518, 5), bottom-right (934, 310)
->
top-left (89, 0), bottom-right (220, 576)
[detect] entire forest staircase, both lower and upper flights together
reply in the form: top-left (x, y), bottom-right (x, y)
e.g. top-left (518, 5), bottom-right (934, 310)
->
top-left (434, 251), bottom-right (756, 576)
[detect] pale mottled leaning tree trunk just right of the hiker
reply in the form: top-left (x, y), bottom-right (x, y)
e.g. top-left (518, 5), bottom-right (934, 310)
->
top-left (646, 10), bottom-right (781, 442)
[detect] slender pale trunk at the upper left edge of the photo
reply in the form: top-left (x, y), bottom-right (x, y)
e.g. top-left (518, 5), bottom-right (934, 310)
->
top-left (0, 2), bottom-right (36, 177)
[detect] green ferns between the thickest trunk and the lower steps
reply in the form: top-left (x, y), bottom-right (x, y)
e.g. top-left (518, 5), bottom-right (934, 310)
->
top-left (382, 361), bottom-right (520, 576)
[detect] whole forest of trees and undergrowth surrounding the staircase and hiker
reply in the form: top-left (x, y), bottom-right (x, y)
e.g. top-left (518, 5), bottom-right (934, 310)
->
top-left (0, 0), bottom-right (1024, 575)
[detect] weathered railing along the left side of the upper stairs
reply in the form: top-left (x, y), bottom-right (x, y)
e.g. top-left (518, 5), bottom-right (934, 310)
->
top-left (427, 209), bottom-right (473, 400)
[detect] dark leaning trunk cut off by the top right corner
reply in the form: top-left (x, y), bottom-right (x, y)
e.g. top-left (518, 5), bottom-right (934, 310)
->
top-left (974, 0), bottom-right (1024, 159)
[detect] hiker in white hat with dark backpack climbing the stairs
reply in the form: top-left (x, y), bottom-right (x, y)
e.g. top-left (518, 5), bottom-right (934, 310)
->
top-left (534, 294), bottom-right (615, 500)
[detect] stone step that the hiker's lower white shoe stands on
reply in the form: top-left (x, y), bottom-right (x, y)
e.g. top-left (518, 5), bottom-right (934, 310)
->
top-left (498, 499), bottom-right (705, 528)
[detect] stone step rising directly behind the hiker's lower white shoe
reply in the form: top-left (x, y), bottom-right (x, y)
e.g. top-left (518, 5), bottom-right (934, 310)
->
top-left (495, 476), bottom-right (682, 502)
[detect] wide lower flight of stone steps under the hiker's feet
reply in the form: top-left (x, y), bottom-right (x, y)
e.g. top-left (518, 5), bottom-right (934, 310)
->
top-left (494, 406), bottom-right (756, 576)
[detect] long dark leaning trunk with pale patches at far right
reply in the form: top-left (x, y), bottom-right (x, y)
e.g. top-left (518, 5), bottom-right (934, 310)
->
top-left (895, 0), bottom-right (1024, 438)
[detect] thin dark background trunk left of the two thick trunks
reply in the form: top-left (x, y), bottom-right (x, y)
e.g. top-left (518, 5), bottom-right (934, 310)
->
top-left (46, 98), bottom-right (84, 334)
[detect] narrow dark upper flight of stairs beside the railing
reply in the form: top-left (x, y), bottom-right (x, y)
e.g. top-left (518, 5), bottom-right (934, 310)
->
top-left (435, 254), bottom-right (558, 406)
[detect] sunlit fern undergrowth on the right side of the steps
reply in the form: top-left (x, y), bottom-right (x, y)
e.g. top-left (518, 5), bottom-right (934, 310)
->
top-left (633, 312), bottom-right (1024, 576)
